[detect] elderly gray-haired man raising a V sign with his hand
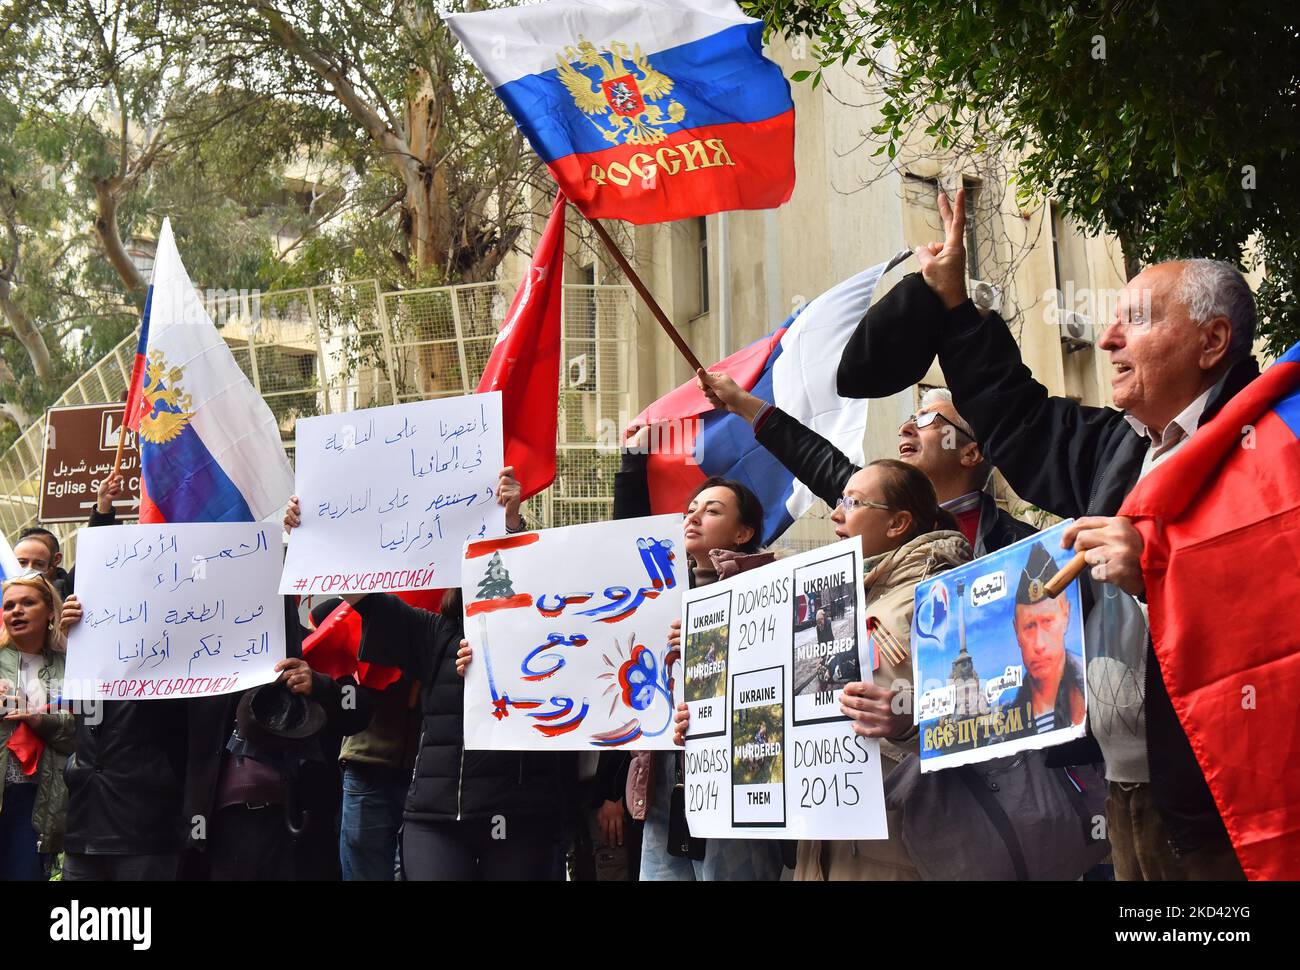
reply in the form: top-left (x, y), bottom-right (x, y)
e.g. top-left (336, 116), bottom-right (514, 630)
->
top-left (837, 191), bottom-right (1258, 880)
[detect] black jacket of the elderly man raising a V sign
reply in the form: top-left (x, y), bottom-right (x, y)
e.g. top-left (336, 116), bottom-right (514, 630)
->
top-left (841, 274), bottom-right (1258, 852)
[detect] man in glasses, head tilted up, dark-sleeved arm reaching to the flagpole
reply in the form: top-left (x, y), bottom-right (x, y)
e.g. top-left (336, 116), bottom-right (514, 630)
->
top-left (697, 371), bottom-right (1036, 557)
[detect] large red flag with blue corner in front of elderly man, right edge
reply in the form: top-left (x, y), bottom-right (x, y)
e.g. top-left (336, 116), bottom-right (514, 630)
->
top-left (1119, 343), bottom-right (1300, 879)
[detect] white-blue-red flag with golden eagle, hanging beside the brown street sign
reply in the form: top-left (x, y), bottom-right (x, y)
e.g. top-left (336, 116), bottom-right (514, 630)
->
top-left (126, 220), bottom-right (294, 523)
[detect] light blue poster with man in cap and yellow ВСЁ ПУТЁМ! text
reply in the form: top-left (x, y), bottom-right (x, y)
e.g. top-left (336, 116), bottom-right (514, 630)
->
top-left (911, 521), bottom-right (1088, 771)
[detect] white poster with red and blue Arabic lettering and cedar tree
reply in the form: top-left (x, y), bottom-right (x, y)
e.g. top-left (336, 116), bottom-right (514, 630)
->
top-left (462, 515), bottom-right (688, 752)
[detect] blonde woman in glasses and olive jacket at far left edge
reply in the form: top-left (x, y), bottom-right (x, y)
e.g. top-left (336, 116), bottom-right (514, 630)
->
top-left (0, 572), bottom-right (81, 882)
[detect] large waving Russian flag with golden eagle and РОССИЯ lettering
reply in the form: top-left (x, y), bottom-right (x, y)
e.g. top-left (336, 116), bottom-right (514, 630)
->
top-left (443, 0), bottom-right (794, 224)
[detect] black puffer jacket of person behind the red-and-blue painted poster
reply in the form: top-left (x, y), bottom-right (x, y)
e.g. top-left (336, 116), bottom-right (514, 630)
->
top-left (356, 593), bottom-right (577, 824)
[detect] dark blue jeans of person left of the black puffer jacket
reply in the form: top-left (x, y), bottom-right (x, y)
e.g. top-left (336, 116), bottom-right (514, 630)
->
top-left (338, 762), bottom-right (408, 883)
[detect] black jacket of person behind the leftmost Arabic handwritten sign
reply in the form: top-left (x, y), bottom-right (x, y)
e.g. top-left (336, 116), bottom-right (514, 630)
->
top-left (64, 501), bottom-right (187, 856)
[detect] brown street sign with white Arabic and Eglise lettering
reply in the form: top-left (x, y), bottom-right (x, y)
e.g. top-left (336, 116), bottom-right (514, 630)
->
top-left (40, 402), bottom-right (140, 523)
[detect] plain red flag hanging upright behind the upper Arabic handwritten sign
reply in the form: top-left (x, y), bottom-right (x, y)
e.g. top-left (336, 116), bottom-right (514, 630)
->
top-left (478, 192), bottom-right (566, 498)
